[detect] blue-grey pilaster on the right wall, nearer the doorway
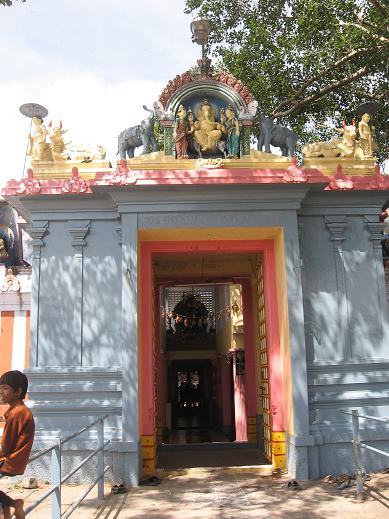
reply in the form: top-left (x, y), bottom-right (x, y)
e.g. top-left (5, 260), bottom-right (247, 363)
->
top-left (324, 216), bottom-right (351, 360)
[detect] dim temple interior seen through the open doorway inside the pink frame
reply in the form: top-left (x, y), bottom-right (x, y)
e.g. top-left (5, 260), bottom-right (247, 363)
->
top-left (153, 253), bottom-right (272, 468)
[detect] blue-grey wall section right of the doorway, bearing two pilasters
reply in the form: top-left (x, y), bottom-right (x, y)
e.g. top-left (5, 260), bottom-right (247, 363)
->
top-left (299, 193), bottom-right (389, 477)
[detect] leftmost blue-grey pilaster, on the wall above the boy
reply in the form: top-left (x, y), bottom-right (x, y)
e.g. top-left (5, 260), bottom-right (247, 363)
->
top-left (28, 220), bottom-right (49, 368)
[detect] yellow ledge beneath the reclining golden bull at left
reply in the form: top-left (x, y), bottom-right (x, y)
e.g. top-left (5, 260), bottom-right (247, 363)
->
top-left (31, 160), bottom-right (113, 180)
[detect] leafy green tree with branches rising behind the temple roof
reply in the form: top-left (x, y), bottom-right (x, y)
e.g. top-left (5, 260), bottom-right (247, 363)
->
top-left (186, 0), bottom-right (389, 153)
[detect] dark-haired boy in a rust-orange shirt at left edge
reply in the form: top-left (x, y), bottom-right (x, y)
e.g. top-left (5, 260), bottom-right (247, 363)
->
top-left (0, 370), bottom-right (35, 519)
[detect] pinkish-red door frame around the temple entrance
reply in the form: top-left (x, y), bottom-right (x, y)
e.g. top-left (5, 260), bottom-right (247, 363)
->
top-left (138, 240), bottom-right (285, 436)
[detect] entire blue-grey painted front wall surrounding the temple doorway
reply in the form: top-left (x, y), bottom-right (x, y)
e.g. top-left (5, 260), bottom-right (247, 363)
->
top-left (14, 185), bottom-right (389, 484)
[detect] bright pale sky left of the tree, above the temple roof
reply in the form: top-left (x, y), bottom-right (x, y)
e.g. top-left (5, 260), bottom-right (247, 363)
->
top-left (0, 0), bottom-right (201, 186)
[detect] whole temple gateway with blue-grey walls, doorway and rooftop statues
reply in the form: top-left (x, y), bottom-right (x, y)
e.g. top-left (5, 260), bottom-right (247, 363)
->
top-left (1, 21), bottom-right (389, 485)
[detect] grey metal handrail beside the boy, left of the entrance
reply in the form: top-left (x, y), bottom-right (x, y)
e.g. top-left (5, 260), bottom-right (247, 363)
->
top-left (16, 415), bottom-right (111, 519)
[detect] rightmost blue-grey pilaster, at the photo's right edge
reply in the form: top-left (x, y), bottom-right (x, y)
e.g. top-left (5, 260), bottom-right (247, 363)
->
top-left (365, 216), bottom-right (387, 340)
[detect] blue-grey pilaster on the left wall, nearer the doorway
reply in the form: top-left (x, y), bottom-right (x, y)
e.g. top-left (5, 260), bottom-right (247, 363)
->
top-left (68, 220), bottom-right (90, 366)
